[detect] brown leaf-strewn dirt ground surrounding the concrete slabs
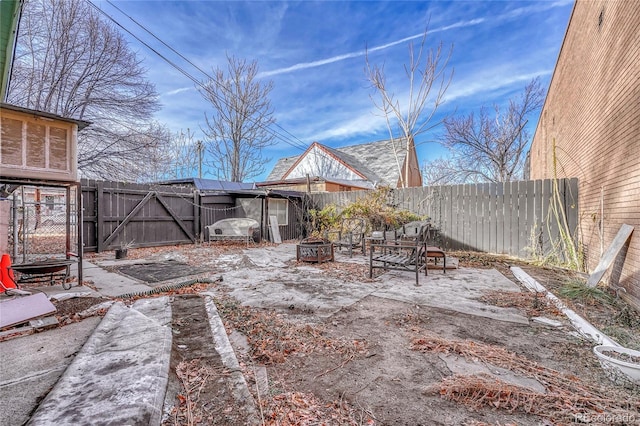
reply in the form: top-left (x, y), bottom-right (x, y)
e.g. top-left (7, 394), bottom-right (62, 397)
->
top-left (51, 244), bottom-right (640, 425)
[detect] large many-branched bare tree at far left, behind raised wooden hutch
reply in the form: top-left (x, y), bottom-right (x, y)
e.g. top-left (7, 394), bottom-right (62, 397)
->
top-left (8, 0), bottom-right (166, 180)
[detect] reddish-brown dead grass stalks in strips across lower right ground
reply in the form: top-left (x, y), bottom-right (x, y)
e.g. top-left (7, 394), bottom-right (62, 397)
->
top-left (412, 332), bottom-right (640, 424)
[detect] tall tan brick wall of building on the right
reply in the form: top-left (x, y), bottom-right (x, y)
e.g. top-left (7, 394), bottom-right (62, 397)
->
top-left (530, 0), bottom-right (640, 309)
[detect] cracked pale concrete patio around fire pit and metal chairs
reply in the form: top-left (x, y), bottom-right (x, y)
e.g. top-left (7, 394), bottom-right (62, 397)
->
top-left (208, 244), bottom-right (529, 324)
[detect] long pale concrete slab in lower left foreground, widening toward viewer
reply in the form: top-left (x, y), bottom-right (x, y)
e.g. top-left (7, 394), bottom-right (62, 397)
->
top-left (28, 297), bottom-right (171, 425)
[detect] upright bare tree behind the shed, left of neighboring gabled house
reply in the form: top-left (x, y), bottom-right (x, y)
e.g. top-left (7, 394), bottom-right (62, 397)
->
top-left (198, 55), bottom-right (275, 182)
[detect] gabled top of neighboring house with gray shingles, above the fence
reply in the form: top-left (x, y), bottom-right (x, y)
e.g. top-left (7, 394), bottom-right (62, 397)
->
top-left (267, 139), bottom-right (407, 187)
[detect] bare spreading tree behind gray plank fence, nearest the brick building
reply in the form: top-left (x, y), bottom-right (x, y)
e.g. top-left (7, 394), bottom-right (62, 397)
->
top-left (425, 78), bottom-right (544, 184)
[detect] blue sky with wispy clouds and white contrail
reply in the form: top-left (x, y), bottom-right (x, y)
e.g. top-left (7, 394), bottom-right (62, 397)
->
top-left (94, 0), bottom-right (573, 181)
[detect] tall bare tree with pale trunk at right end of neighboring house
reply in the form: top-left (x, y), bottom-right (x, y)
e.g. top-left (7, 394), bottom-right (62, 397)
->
top-left (365, 31), bottom-right (453, 187)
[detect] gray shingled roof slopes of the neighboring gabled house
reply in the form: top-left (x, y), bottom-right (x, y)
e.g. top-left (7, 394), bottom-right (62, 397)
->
top-left (267, 140), bottom-right (406, 187)
